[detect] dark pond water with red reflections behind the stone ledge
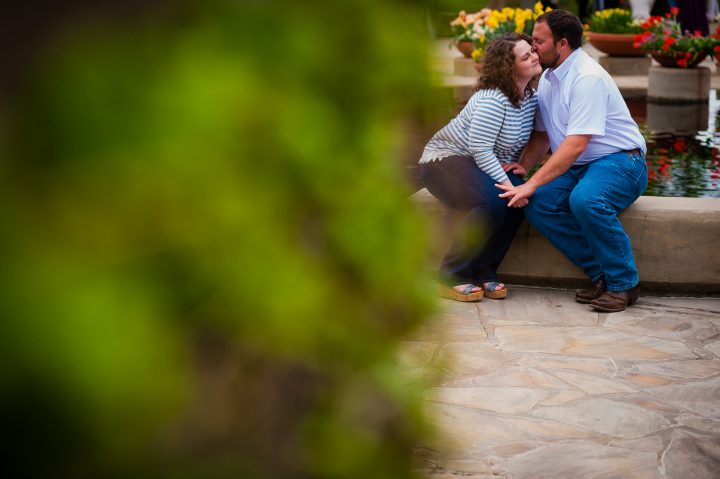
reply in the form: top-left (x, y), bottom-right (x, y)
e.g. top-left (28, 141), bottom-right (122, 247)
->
top-left (627, 90), bottom-right (720, 198)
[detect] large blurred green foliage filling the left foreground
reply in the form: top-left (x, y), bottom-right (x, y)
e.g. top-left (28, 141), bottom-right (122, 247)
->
top-left (0, 0), bottom-right (432, 478)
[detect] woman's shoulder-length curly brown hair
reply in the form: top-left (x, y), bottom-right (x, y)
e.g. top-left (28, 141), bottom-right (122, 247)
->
top-left (475, 33), bottom-right (540, 108)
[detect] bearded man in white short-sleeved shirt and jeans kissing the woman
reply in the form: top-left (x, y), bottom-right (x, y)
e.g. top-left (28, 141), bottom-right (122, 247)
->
top-left (496, 10), bottom-right (647, 312)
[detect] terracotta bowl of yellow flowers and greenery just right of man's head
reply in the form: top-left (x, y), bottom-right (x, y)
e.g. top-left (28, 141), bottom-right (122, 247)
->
top-left (587, 8), bottom-right (645, 57)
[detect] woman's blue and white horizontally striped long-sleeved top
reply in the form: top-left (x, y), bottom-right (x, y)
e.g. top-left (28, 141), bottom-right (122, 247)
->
top-left (420, 88), bottom-right (537, 183)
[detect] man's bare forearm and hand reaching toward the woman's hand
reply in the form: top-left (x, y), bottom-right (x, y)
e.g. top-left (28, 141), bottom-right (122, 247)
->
top-left (495, 135), bottom-right (591, 206)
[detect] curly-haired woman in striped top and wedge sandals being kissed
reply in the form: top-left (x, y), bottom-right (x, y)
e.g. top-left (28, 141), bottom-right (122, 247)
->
top-left (420, 33), bottom-right (542, 301)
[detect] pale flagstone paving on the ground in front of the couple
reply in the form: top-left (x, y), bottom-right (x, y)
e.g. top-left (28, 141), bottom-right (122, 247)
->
top-left (408, 287), bottom-right (720, 479)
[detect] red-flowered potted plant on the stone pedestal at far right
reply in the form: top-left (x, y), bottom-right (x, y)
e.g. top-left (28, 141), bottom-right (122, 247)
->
top-left (635, 7), bottom-right (720, 68)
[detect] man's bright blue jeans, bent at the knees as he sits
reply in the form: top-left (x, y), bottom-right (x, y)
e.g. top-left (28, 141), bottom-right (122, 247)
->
top-left (525, 152), bottom-right (647, 291)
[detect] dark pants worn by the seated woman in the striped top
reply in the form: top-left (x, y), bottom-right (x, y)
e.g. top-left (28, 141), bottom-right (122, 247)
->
top-left (420, 156), bottom-right (523, 285)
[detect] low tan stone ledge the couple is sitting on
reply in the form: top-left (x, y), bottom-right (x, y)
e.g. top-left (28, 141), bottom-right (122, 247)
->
top-left (411, 188), bottom-right (720, 295)
